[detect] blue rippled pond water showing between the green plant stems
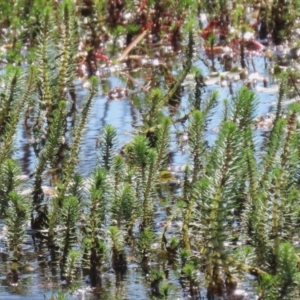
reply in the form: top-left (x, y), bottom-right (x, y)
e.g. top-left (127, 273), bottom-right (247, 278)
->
top-left (0, 39), bottom-right (292, 300)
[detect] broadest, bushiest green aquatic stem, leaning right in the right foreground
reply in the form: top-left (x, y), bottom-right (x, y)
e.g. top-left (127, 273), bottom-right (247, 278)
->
top-left (194, 121), bottom-right (242, 294)
